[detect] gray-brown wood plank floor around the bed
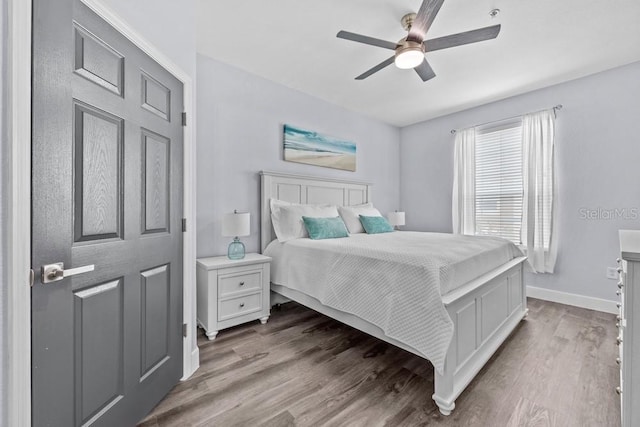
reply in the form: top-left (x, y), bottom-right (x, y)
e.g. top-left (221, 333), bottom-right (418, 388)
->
top-left (140, 299), bottom-right (620, 427)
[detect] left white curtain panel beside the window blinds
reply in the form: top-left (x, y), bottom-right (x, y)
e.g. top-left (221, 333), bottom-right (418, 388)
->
top-left (452, 128), bottom-right (476, 234)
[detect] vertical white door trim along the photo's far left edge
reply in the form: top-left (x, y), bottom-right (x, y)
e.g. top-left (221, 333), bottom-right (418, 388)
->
top-left (5, 0), bottom-right (31, 426)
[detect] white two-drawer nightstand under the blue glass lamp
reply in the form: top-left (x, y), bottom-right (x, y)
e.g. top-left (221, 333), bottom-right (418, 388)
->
top-left (196, 254), bottom-right (271, 340)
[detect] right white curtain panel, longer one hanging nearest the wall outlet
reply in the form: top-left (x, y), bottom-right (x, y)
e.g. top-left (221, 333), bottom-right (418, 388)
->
top-left (522, 110), bottom-right (558, 273)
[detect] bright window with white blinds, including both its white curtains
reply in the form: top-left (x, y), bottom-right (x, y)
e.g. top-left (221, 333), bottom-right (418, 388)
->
top-left (452, 108), bottom-right (558, 273)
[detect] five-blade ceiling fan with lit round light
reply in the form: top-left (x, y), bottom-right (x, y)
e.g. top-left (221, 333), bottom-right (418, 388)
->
top-left (337, 0), bottom-right (500, 82)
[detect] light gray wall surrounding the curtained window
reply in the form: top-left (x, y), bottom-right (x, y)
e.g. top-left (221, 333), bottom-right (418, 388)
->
top-left (400, 63), bottom-right (640, 300)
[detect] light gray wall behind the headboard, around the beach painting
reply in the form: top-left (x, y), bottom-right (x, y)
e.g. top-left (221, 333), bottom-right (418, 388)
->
top-left (197, 55), bottom-right (400, 257)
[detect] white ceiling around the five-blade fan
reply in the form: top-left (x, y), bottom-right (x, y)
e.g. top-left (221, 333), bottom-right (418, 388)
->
top-left (197, 0), bottom-right (640, 126)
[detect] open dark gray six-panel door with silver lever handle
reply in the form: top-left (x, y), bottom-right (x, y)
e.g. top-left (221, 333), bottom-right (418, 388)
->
top-left (32, 0), bottom-right (183, 426)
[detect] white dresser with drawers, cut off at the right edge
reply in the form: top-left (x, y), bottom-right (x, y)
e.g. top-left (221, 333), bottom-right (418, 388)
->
top-left (616, 230), bottom-right (640, 427)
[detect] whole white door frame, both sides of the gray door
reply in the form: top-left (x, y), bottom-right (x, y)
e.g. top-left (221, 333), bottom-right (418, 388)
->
top-left (5, 0), bottom-right (199, 425)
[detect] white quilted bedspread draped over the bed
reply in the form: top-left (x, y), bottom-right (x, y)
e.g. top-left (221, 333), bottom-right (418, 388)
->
top-left (264, 231), bottom-right (522, 373)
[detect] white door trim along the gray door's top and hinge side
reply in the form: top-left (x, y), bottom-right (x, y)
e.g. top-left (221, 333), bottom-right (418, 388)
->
top-left (81, 0), bottom-right (200, 380)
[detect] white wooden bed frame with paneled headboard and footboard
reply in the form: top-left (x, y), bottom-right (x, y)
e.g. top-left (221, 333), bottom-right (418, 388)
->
top-left (260, 172), bottom-right (528, 415)
